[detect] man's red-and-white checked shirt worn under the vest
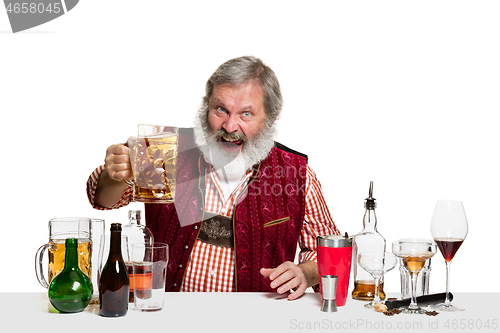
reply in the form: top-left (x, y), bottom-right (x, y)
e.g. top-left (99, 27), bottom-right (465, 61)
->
top-left (87, 165), bottom-right (340, 292)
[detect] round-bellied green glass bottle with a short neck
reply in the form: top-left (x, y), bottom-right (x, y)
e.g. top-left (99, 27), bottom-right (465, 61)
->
top-left (49, 238), bottom-right (93, 313)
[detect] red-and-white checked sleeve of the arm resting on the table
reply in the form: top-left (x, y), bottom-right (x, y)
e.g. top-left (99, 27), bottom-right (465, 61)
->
top-left (299, 166), bottom-right (340, 263)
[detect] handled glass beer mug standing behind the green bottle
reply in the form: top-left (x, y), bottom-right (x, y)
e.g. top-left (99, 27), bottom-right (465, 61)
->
top-left (35, 217), bottom-right (94, 288)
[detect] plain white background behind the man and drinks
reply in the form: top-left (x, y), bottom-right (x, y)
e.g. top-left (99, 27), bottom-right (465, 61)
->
top-left (0, 0), bottom-right (500, 292)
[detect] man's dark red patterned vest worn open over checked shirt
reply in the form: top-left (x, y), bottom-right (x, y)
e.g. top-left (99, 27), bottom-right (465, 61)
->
top-left (145, 129), bottom-right (307, 292)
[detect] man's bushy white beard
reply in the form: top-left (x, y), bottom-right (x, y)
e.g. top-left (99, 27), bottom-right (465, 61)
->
top-left (194, 109), bottom-right (276, 182)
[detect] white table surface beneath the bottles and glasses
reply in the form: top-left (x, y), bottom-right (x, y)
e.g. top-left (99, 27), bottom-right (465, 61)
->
top-left (0, 292), bottom-right (500, 333)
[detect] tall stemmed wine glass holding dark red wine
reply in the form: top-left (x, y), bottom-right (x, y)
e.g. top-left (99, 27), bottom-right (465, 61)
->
top-left (431, 200), bottom-right (468, 311)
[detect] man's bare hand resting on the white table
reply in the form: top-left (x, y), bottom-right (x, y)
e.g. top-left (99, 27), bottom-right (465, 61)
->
top-left (260, 261), bottom-right (319, 300)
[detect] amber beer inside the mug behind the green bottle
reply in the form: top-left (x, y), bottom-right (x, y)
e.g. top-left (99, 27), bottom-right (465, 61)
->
top-left (48, 239), bottom-right (92, 283)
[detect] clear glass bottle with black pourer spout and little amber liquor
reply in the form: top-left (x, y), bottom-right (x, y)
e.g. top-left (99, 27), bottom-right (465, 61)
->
top-left (352, 182), bottom-right (385, 301)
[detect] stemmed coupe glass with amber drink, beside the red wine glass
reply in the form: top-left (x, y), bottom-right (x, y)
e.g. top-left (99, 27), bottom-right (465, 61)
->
top-left (392, 238), bottom-right (436, 314)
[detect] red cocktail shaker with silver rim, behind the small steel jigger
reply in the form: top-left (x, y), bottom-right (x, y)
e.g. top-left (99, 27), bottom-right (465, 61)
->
top-left (316, 235), bottom-right (352, 306)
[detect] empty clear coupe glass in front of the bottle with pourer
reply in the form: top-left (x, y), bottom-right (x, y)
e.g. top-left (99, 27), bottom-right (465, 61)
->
top-left (358, 251), bottom-right (397, 309)
